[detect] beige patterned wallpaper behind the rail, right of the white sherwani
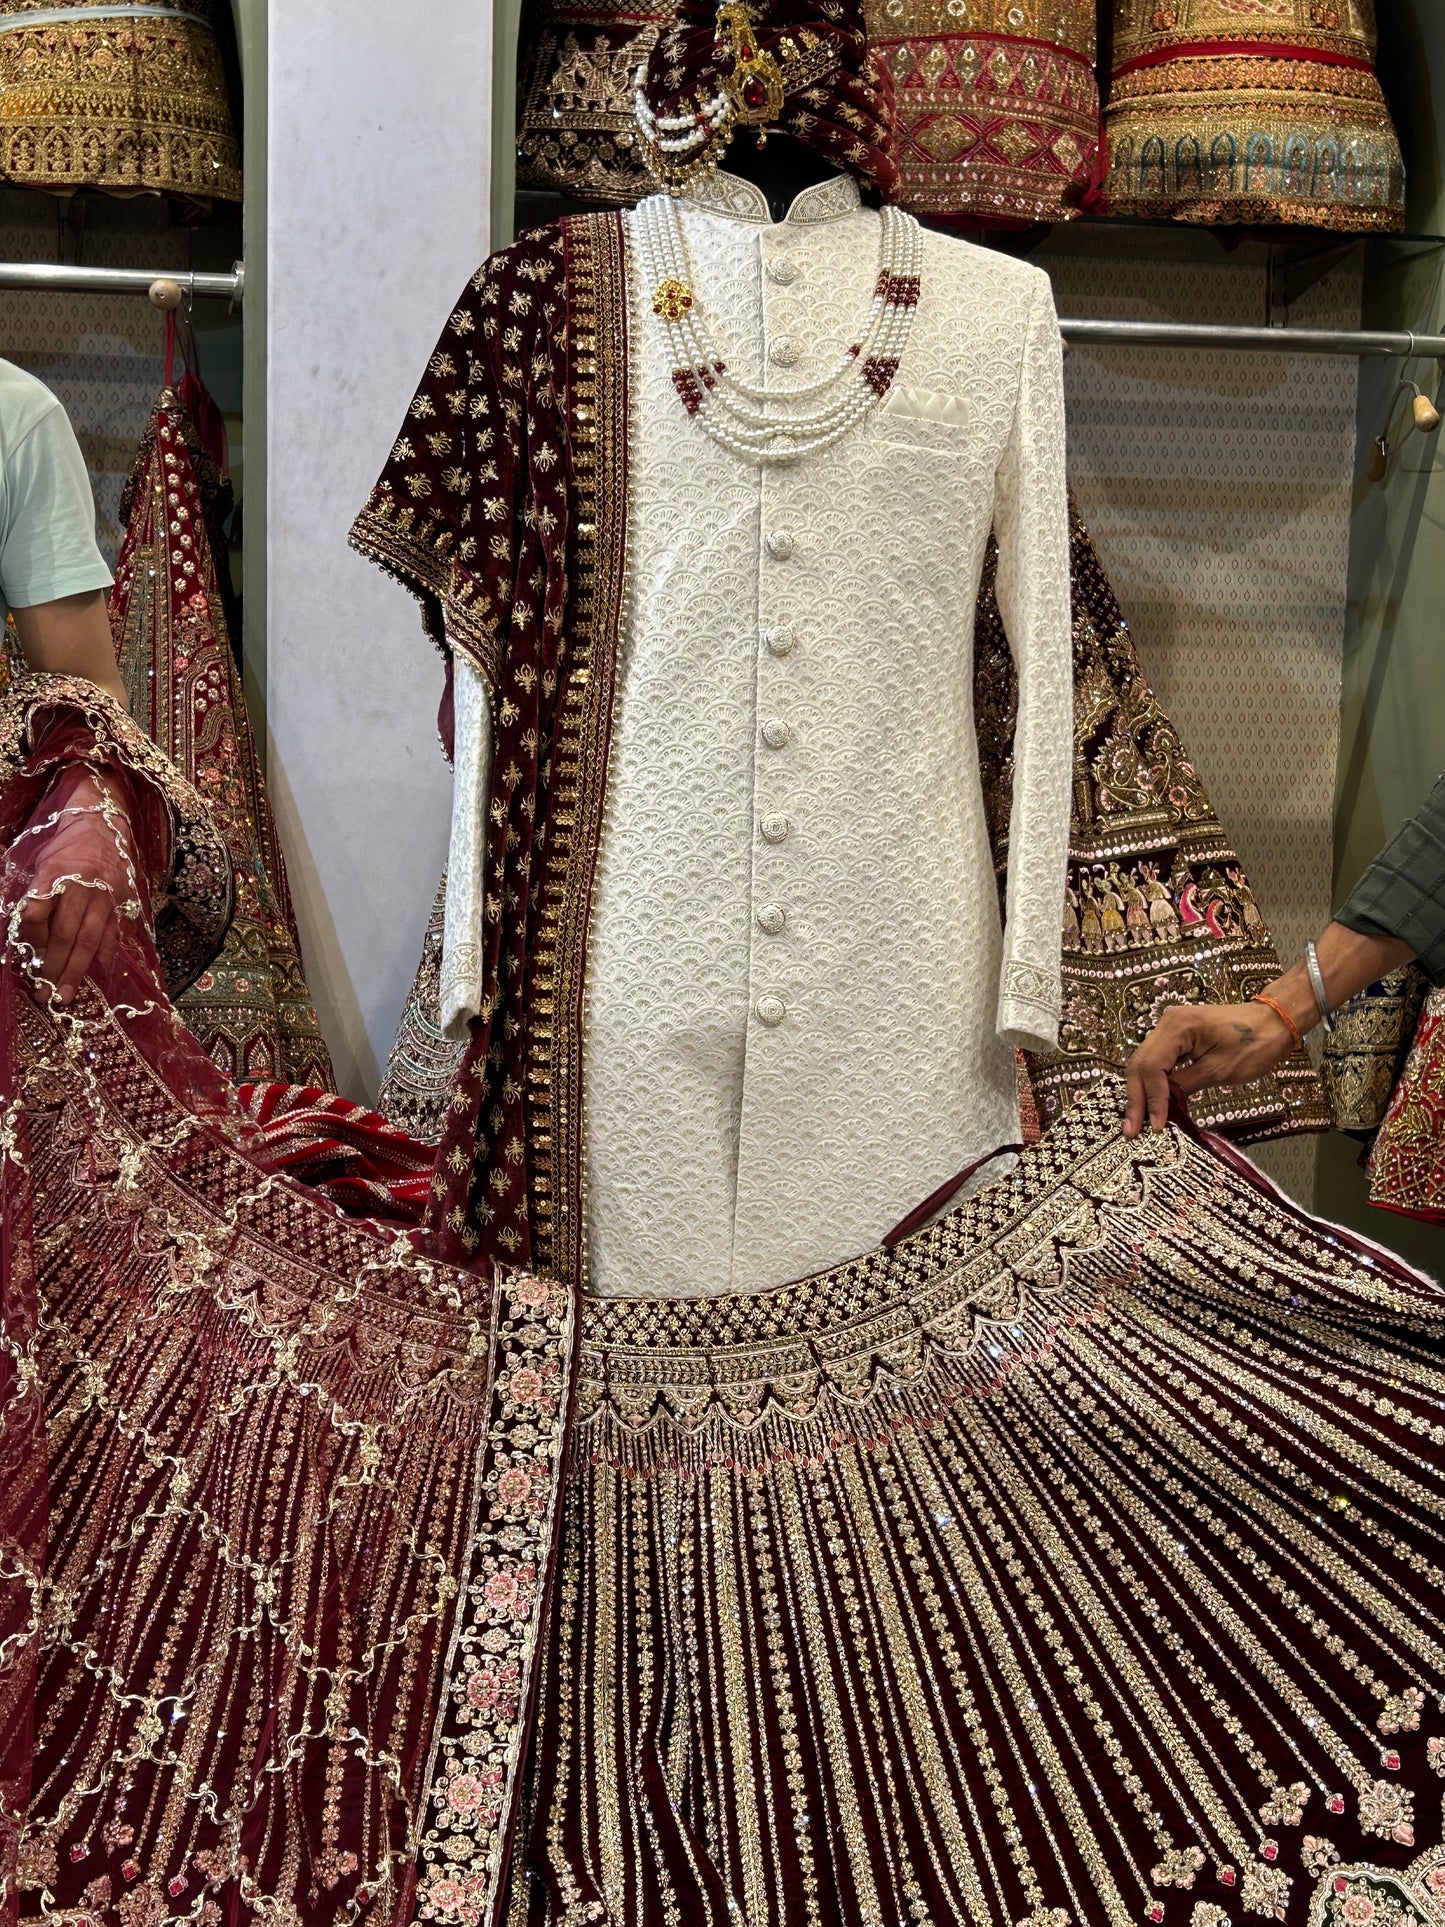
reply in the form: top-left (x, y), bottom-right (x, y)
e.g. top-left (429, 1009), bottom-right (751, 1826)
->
top-left (1033, 227), bottom-right (1360, 1202)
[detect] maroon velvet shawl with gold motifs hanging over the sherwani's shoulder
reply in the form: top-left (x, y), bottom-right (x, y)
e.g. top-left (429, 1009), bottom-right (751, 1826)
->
top-left (351, 214), bottom-right (628, 1283)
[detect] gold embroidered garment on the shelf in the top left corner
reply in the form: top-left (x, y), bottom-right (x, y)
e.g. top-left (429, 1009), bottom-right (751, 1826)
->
top-left (0, 0), bottom-right (241, 204)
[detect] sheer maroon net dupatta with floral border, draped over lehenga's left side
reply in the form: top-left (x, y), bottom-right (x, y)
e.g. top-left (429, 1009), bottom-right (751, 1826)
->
top-left (0, 676), bottom-right (572, 1927)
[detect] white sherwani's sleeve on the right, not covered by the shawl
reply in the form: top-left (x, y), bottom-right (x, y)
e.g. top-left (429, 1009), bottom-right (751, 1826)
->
top-left (994, 276), bottom-right (1073, 1050)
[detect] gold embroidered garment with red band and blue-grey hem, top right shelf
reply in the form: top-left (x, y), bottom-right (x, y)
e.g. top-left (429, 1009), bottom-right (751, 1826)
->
top-left (1104, 0), bottom-right (1405, 231)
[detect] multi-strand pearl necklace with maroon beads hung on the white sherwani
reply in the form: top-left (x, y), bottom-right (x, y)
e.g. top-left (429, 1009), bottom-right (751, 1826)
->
top-left (638, 195), bottom-right (923, 462)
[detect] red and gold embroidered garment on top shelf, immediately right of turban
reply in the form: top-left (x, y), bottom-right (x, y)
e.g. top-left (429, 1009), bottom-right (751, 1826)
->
top-left (867, 0), bottom-right (1100, 222)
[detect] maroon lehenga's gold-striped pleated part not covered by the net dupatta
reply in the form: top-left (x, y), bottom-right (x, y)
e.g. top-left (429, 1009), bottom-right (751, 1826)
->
top-left (514, 1093), bottom-right (1445, 1927)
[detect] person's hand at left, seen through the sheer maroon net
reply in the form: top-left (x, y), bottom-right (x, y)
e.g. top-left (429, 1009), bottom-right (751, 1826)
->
top-left (15, 775), bottom-right (139, 1004)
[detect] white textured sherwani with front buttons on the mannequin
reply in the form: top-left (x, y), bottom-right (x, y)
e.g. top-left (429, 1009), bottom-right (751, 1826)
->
top-left (443, 175), bottom-right (1071, 1297)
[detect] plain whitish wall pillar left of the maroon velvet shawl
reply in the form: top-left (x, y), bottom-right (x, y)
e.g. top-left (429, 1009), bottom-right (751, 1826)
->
top-left (266, 0), bottom-right (491, 1098)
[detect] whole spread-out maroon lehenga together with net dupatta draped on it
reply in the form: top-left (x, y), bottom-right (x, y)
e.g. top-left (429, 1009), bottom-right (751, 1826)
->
top-left (0, 678), bottom-right (1445, 1927)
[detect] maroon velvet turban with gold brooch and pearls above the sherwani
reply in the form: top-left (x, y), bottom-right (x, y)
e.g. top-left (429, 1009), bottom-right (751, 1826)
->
top-left (642, 0), bottom-right (900, 200)
